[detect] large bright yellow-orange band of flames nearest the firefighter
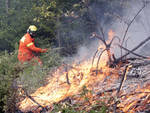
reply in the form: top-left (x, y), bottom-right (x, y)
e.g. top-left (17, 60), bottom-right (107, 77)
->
top-left (19, 57), bottom-right (111, 112)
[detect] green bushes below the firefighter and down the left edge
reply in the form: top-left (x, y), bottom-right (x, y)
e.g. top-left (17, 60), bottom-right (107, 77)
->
top-left (0, 51), bottom-right (61, 113)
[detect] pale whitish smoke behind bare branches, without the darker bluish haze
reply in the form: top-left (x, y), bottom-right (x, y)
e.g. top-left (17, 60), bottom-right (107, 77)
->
top-left (64, 0), bottom-right (150, 62)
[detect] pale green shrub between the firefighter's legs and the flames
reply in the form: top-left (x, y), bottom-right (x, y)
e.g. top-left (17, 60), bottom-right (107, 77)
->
top-left (18, 50), bottom-right (61, 92)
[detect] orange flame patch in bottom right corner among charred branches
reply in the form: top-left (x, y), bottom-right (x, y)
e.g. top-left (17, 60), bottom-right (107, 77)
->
top-left (118, 84), bottom-right (150, 113)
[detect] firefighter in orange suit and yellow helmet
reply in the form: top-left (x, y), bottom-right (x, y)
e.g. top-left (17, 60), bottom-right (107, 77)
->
top-left (18, 25), bottom-right (47, 65)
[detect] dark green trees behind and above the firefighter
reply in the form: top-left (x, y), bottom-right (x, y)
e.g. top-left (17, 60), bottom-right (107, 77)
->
top-left (0, 0), bottom-right (125, 56)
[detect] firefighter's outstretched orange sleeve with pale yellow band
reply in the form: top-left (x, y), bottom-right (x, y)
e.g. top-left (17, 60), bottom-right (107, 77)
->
top-left (27, 42), bottom-right (47, 53)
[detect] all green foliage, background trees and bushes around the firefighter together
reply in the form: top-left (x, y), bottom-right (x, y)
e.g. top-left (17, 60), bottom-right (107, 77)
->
top-left (0, 0), bottom-right (126, 113)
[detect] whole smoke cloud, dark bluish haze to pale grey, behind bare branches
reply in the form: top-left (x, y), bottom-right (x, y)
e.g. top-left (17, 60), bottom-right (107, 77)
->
top-left (63, 0), bottom-right (150, 62)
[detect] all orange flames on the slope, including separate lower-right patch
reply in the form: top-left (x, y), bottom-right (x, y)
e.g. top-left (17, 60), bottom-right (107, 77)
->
top-left (19, 30), bottom-right (150, 113)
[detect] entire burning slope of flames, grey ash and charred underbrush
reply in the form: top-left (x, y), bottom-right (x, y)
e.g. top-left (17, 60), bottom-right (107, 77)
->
top-left (19, 54), bottom-right (150, 113)
